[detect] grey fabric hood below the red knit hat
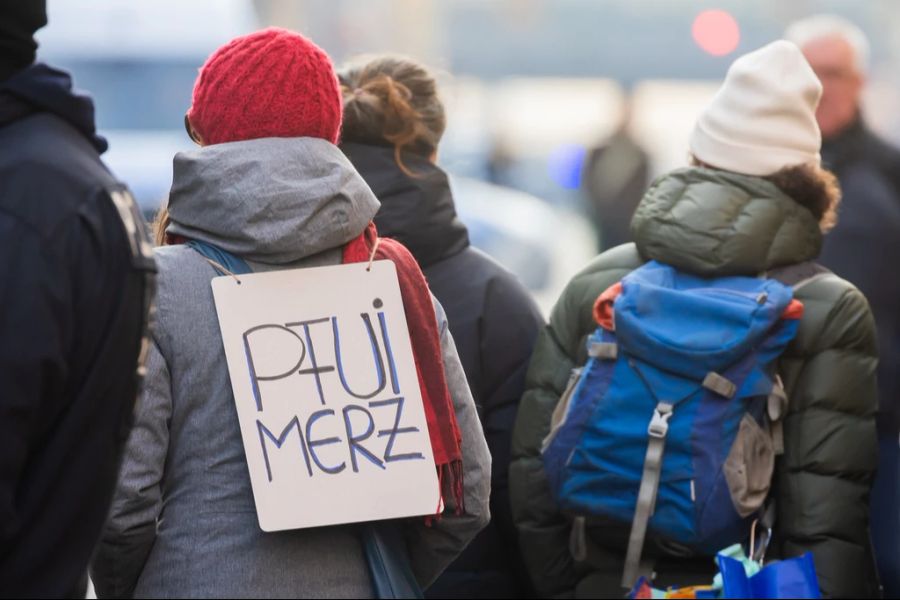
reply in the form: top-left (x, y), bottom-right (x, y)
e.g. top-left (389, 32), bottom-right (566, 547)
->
top-left (167, 138), bottom-right (379, 265)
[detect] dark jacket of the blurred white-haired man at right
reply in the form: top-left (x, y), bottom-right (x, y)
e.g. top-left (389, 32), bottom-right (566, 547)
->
top-left (819, 120), bottom-right (900, 438)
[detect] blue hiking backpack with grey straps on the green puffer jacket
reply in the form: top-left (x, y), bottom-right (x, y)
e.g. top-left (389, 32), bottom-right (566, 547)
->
top-left (542, 262), bottom-right (803, 588)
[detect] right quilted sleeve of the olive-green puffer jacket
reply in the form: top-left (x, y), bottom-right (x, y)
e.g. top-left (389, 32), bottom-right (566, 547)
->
top-left (776, 276), bottom-right (879, 597)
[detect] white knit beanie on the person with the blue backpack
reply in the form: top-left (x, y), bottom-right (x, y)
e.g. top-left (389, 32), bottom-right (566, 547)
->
top-left (690, 40), bottom-right (822, 176)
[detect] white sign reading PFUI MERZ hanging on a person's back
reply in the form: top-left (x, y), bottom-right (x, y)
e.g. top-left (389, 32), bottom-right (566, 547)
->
top-left (212, 260), bottom-right (440, 531)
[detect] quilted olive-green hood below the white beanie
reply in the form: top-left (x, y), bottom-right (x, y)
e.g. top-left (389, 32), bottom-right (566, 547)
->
top-left (631, 168), bottom-right (822, 277)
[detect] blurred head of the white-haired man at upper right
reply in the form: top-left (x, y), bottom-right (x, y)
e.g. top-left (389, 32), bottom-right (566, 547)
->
top-left (785, 15), bottom-right (869, 139)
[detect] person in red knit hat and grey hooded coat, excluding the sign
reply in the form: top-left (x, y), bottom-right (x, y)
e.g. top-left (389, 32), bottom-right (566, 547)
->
top-left (91, 29), bottom-right (490, 598)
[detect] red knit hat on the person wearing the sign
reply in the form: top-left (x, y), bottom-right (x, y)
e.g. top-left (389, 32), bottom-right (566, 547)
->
top-left (188, 27), bottom-right (343, 144)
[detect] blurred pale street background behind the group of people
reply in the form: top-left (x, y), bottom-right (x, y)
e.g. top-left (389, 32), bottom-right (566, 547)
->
top-left (38, 0), bottom-right (900, 310)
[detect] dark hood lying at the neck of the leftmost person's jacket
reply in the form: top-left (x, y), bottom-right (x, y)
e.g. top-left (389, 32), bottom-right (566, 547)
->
top-left (0, 63), bottom-right (109, 154)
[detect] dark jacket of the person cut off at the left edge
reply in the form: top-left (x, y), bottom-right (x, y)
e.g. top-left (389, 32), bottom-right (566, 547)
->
top-left (0, 64), bottom-right (153, 597)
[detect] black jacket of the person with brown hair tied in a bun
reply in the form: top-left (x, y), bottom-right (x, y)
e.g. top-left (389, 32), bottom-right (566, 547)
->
top-left (341, 143), bottom-right (544, 598)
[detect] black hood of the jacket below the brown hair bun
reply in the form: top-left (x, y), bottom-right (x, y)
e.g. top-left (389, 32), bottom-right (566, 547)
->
top-left (341, 143), bottom-right (469, 268)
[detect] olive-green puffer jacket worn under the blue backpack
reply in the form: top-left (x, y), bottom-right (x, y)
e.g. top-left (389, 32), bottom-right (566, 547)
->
top-left (509, 168), bottom-right (878, 597)
